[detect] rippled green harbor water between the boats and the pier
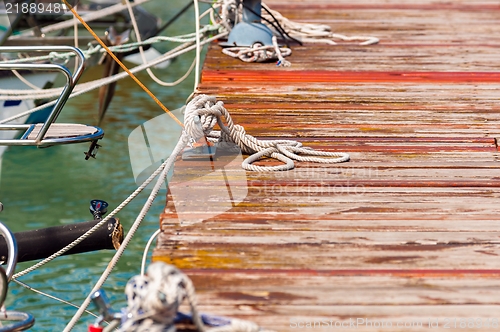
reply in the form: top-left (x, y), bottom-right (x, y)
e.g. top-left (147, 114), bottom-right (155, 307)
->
top-left (0, 0), bottom-right (206, 331)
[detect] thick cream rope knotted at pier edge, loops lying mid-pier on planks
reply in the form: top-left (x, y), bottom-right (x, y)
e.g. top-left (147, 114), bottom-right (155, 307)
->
top-left (184, 95), bottom-right (349, 172)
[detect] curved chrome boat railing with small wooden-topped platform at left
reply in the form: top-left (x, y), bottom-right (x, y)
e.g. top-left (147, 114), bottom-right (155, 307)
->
top-left (0, 46), bottom-right (104, 147)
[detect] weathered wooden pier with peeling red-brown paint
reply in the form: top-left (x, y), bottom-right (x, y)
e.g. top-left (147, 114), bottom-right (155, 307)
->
top-left (154, 0), bottom-right (500, 331)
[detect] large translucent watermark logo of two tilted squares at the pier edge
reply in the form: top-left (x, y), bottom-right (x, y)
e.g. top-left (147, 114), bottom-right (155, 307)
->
top-left (128, 109), bottom-right (248, 221)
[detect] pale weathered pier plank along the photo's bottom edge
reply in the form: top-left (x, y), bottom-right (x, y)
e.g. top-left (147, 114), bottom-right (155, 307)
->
top-left (180, 302), bottom-right (498, 332)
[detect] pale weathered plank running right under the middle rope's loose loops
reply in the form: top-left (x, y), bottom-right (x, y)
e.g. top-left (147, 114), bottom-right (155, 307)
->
top-left (171, 161), bottom-right (500, 180)
